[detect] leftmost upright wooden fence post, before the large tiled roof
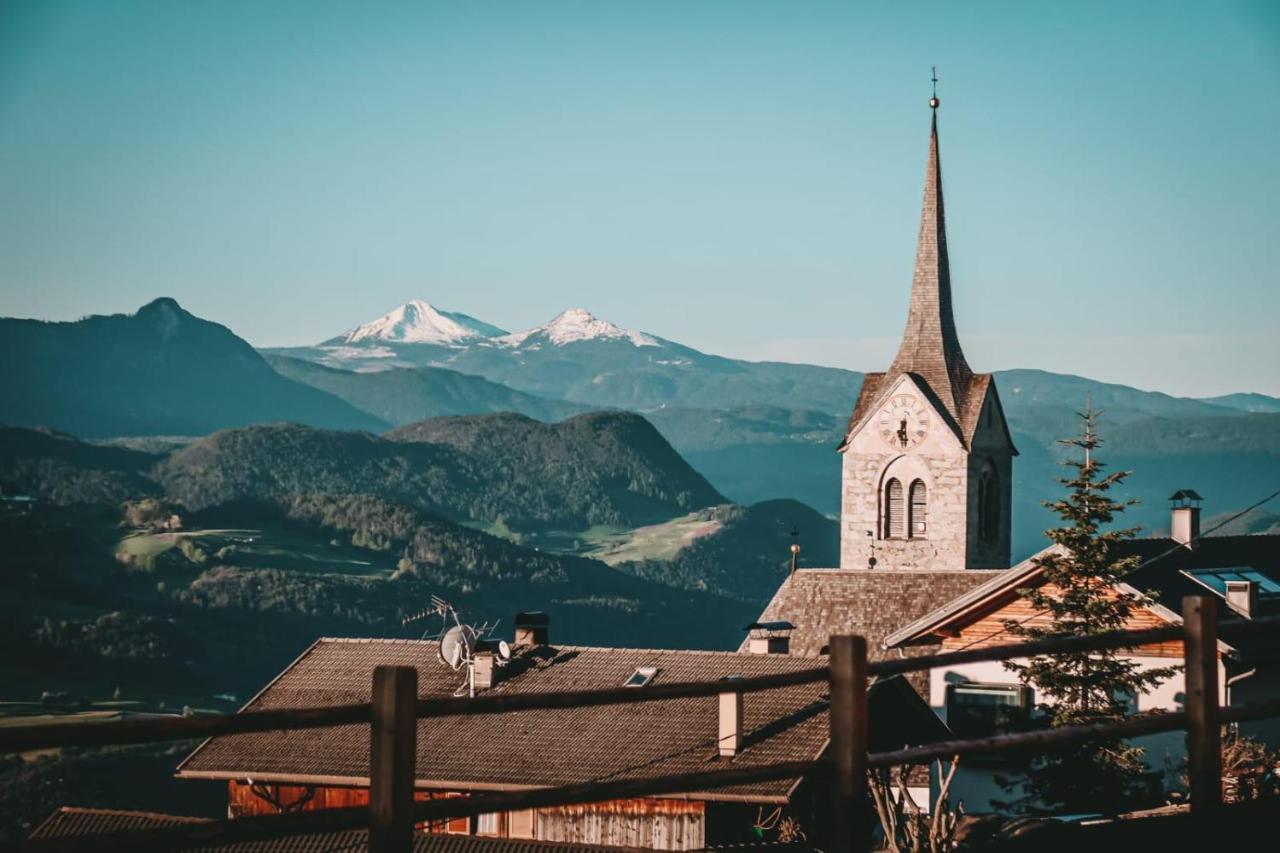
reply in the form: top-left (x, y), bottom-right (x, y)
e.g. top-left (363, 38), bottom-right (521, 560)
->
top-left (369, 666), bottom-right (417, 853)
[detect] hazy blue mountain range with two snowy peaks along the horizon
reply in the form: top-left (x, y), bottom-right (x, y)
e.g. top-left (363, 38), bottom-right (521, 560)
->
top-left (0, 300), bottom-right (1280, 553)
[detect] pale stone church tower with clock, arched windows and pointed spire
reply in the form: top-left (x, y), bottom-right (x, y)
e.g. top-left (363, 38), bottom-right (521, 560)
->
top-left (840, 95), bottom-right (1018, 570)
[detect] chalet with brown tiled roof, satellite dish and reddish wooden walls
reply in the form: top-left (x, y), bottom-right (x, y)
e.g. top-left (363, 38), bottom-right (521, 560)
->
top-left (177, 614), bottom-right (950, 850)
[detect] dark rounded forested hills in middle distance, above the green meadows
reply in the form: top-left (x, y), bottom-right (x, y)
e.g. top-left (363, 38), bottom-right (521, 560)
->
top-left (154, 412), bottom-right (723, 530)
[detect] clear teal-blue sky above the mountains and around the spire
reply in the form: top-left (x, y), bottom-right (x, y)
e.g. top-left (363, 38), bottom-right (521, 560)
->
top-left (0, 0), bottom-right (1280, 394)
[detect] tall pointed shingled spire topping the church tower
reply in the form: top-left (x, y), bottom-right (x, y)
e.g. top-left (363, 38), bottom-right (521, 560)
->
top-left (888, 80), bottom-right (973, 420)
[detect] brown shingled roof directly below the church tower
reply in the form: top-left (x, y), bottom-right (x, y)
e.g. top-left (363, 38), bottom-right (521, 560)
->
top-left (744, 569), bottom-right (1001, 685)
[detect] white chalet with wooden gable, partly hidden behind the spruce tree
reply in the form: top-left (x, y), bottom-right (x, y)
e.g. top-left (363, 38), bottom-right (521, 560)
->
top-left (883, 489), bottom-right (1280, 812)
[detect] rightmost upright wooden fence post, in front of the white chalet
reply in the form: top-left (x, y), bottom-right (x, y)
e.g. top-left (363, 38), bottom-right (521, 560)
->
top-left (1183, 596), bottom-right (1222, 817)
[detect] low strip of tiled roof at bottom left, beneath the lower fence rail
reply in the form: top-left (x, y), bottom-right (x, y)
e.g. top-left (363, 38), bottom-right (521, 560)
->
top-left (31, 806), bottom-right (645, 853)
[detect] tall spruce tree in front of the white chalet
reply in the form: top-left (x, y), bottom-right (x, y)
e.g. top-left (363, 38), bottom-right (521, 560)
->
top-left (1005, 407), bottom-right (1176, 813)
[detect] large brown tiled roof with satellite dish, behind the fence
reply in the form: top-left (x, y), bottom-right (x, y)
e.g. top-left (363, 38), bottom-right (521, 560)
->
top-left (178, 639), bottom-right (827, 802)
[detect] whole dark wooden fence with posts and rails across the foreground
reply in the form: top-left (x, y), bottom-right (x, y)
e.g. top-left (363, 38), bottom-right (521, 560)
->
top-left (0, 596), bottom-right (1280, 853)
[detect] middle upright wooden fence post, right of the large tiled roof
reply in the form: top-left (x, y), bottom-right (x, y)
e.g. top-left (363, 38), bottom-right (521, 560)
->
top-left (827, 635), bottom-right (872, 853)
